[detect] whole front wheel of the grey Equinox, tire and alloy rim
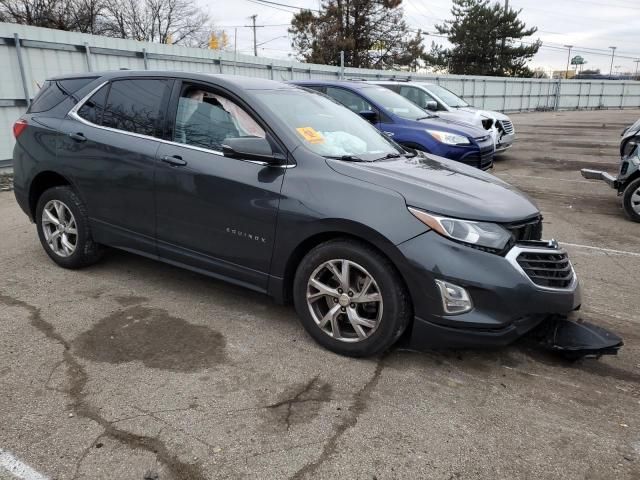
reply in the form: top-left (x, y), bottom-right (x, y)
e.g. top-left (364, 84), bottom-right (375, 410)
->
top-left (293, 240), bottom-right (411, 357)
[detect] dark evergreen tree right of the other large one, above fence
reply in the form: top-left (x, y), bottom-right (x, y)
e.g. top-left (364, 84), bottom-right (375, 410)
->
top-left (425, 0), bottom-right (542, 77)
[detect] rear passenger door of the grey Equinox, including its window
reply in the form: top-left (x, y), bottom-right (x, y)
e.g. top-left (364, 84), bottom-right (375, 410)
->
top-left (58, 78), bottom-right (173, 254)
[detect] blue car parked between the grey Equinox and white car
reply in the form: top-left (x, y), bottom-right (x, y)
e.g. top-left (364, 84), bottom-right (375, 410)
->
top-left (292, 80), bottom-right (494, 170)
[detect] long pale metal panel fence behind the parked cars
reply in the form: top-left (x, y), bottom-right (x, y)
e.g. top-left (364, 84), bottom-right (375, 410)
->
top-left (0, 23), bottom-right (640, 166)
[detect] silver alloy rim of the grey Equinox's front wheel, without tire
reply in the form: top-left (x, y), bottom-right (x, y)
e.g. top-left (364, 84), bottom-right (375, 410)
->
top-left (307, 259), bottom-right (383, 343)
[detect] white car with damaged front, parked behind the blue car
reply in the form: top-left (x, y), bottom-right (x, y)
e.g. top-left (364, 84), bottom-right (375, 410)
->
top-left (375, 80), bottom-right (516, 153)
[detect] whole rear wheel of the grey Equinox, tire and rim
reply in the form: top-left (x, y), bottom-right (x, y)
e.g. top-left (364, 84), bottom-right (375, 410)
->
top-left (36, 186), bottom-right (103, 269)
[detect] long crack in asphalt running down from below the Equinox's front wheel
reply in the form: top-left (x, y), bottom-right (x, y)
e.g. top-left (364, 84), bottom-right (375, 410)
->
top-left (290, 354), bottom-right (387, 480)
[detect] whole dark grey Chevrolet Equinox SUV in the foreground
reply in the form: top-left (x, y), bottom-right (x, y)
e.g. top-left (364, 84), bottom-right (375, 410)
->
top-left (13, 71), bottom-right (580, 356)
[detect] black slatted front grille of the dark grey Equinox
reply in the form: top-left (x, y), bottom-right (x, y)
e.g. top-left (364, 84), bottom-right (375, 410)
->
top-left (516, 250), bottom-right (573, 288)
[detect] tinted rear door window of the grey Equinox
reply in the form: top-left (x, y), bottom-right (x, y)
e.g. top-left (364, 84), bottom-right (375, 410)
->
top-left (102, 79), bottom-right (171, 137)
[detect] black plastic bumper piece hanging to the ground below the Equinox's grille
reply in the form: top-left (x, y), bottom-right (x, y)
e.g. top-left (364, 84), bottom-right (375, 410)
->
top-left (530, 316), bottom-right (624, 360)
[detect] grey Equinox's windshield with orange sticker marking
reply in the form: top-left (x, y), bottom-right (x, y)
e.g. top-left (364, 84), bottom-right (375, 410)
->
top-left (255, 89), bottom-right (402, 161)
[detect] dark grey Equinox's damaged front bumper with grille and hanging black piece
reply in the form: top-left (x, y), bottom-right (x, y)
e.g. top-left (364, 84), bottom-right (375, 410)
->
top-left (400, 232), bottom-right (622, 358)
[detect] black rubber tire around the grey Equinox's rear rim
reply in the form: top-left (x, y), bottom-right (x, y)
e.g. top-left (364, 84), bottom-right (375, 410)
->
top-left (35, 186), bottom-right (104, 269)
